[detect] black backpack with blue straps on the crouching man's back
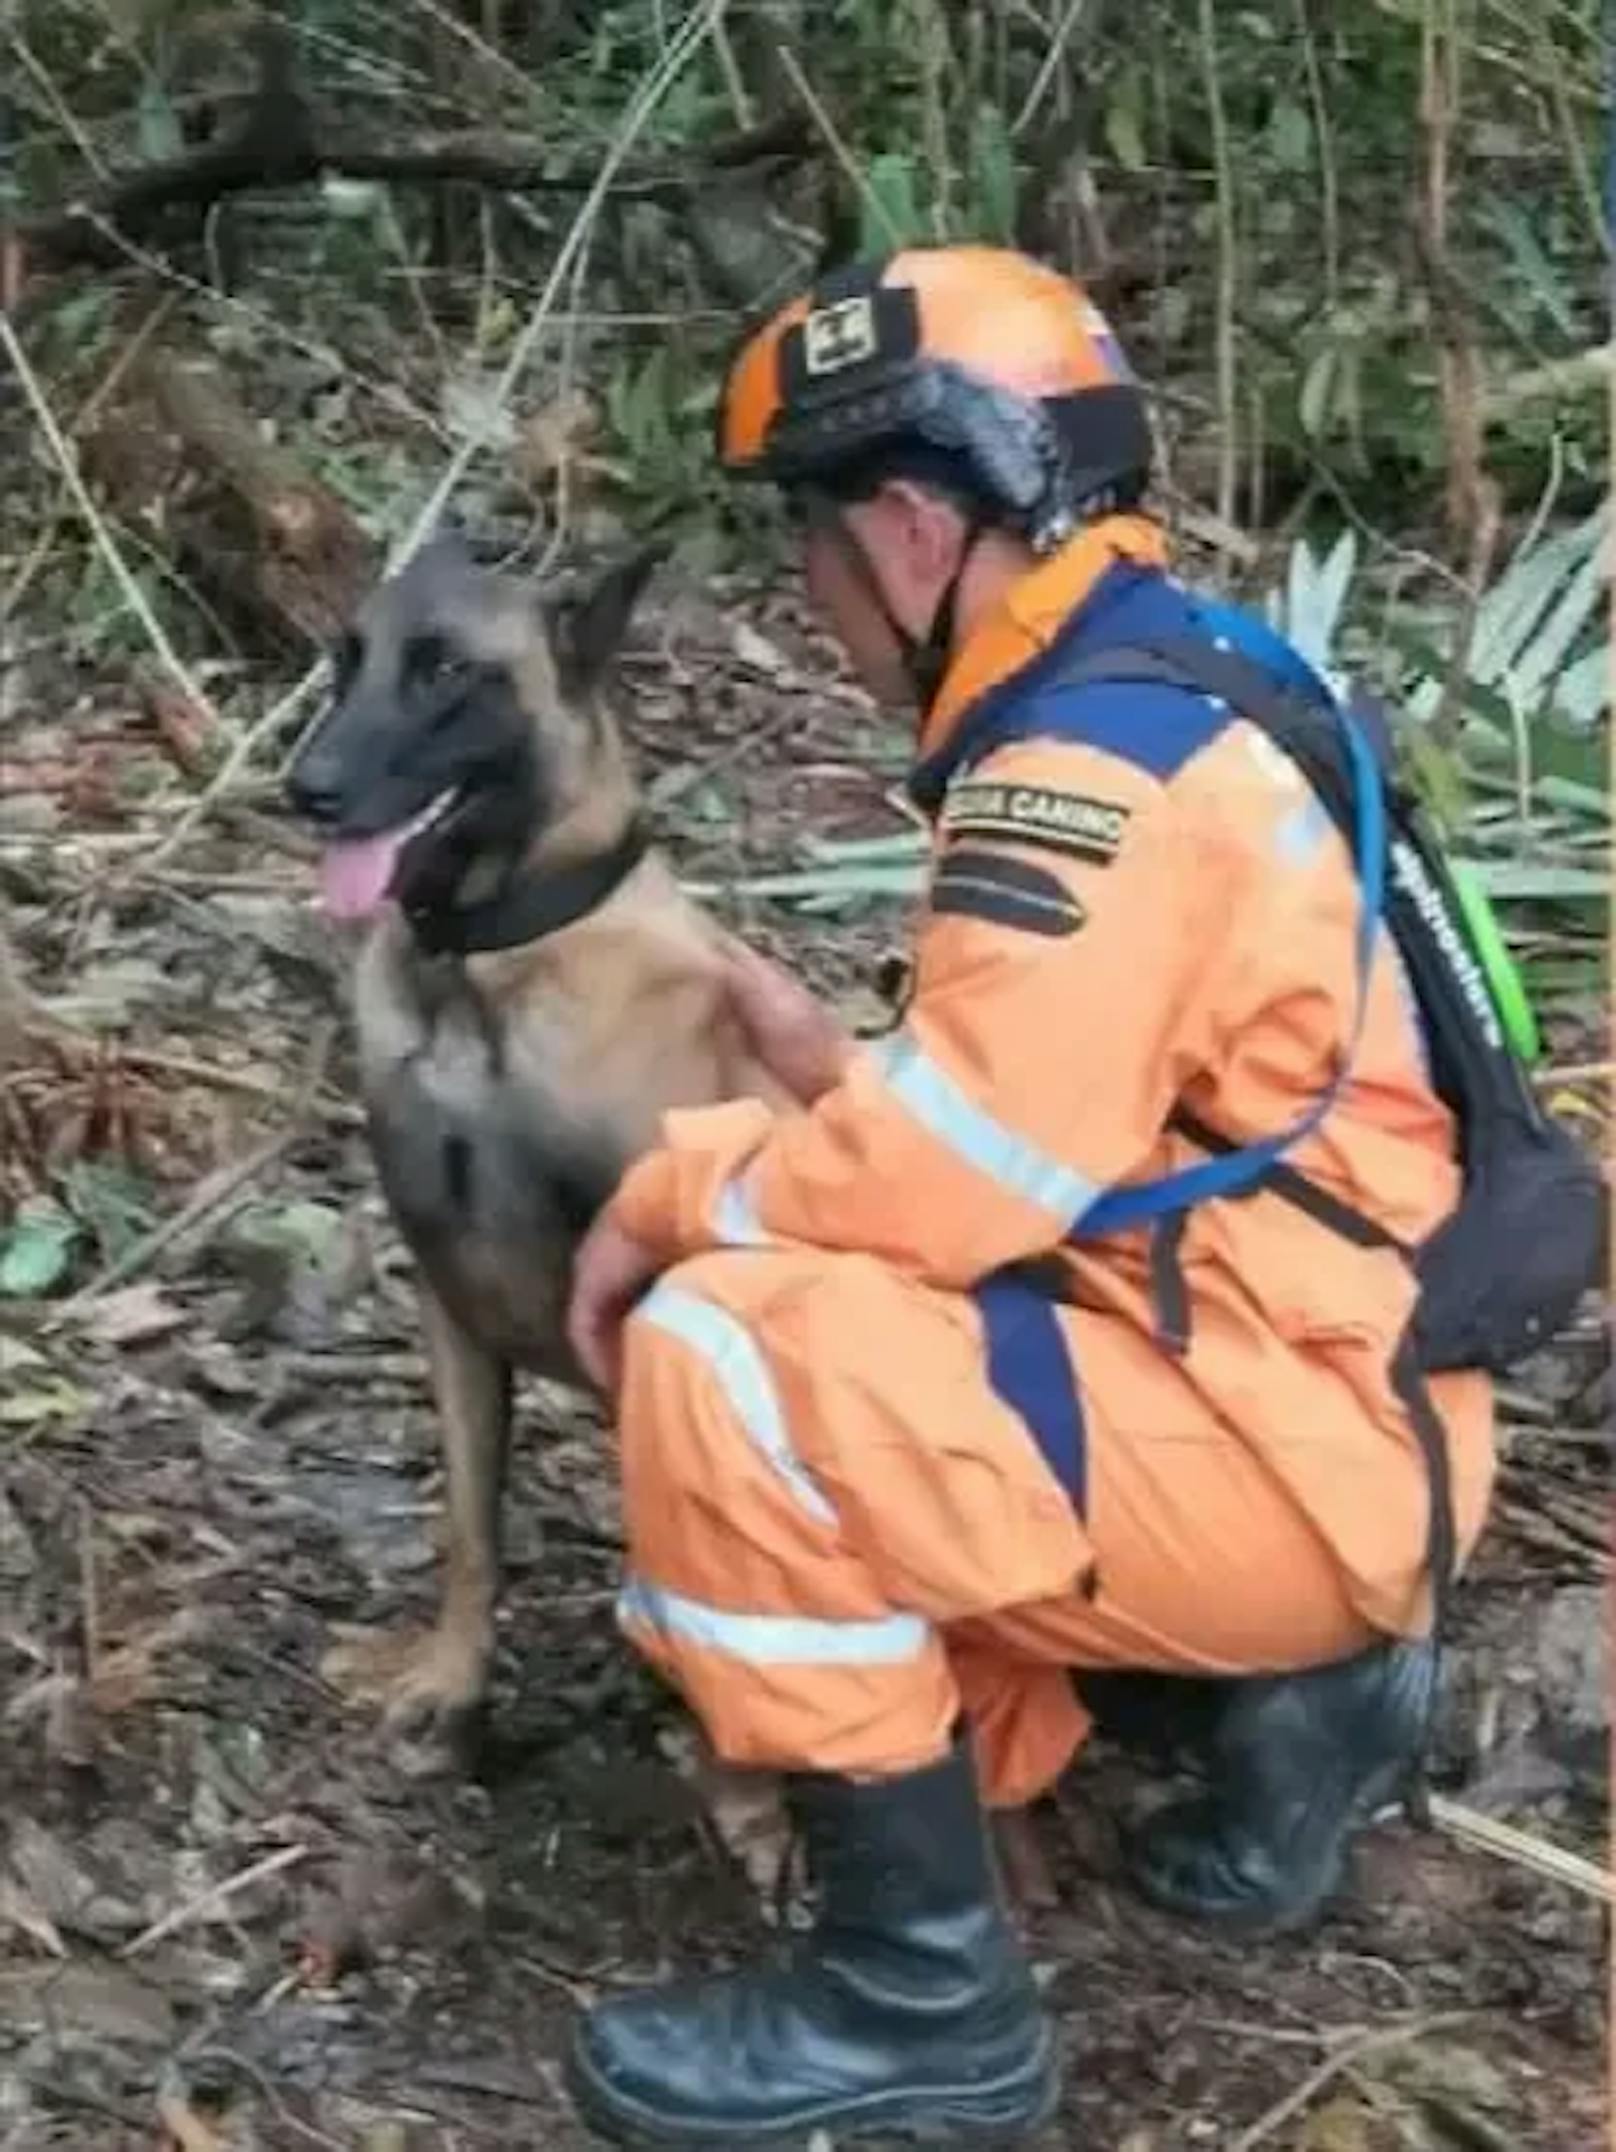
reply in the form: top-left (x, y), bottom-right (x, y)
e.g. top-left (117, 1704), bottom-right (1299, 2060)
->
top-left (1041, 624), bottom-right (1607, 1636)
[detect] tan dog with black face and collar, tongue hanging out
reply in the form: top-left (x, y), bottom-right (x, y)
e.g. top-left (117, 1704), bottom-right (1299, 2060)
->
top-left (286, 536), bottom-right (804, 1887)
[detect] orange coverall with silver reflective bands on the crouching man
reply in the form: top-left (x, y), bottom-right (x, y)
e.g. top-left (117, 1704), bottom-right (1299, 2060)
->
top-left (613, 516), bottom-right (1493, 1806)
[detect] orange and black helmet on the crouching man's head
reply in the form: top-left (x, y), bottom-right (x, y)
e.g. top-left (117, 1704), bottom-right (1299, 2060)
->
top-left (719, 245), bottom-right (1151, 551)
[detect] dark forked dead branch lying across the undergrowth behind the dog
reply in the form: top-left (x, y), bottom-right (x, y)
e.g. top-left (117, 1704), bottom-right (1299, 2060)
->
top-left (15, 22), bottom-right (811, 297)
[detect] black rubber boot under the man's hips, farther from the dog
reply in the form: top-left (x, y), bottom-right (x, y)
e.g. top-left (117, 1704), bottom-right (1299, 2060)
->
top-left (1128, 1642), bottom-right (1435, 1935)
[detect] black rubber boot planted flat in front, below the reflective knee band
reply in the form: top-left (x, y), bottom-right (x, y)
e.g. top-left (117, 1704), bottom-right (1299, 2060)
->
top-left (568, 1743), bottom-right (1057, 2152)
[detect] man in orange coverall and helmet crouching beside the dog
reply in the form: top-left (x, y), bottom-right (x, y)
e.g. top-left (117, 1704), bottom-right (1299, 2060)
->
top-left (570, 247), bottom-right (1491, 2148)
